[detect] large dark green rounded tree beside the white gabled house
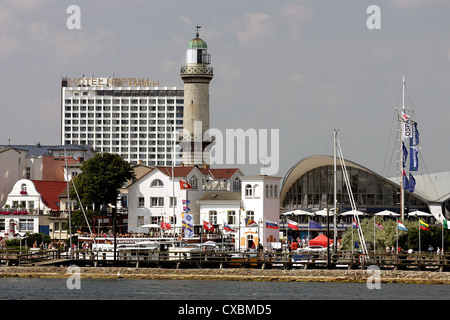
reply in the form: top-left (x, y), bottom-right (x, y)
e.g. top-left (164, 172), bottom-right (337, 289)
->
top-left (71, 153), bottom-right (134, 210)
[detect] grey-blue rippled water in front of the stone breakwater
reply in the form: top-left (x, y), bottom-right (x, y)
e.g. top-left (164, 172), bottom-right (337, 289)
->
top-left (0, 278), bottom-right (450, 301)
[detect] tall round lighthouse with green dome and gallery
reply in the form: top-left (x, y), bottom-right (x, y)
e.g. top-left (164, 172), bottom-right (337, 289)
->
top-left (180, 26), bottom-right (214, 166)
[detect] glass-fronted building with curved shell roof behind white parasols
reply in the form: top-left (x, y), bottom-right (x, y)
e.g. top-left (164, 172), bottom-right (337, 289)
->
top-left (280, 156), bottom-right (450, 221)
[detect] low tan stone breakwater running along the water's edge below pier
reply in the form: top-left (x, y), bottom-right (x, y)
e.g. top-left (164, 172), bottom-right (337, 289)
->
top-left (0, 266), bottom-right (450, 284)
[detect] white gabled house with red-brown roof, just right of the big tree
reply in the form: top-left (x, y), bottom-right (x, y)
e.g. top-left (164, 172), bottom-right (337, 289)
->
top-left (128, 166), bottom-right (242, 233)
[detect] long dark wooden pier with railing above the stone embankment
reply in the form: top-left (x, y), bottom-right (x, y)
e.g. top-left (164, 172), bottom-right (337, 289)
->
top-left (0, 250), bottom-right (450, 272)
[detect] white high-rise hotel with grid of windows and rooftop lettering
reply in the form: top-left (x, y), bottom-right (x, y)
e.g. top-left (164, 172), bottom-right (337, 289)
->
top-left (61, 77), bottom-right (184, 166)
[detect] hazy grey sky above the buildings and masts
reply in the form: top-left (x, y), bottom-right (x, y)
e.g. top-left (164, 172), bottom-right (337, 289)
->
top-left (0, 0), bottom-right (450, 177)
